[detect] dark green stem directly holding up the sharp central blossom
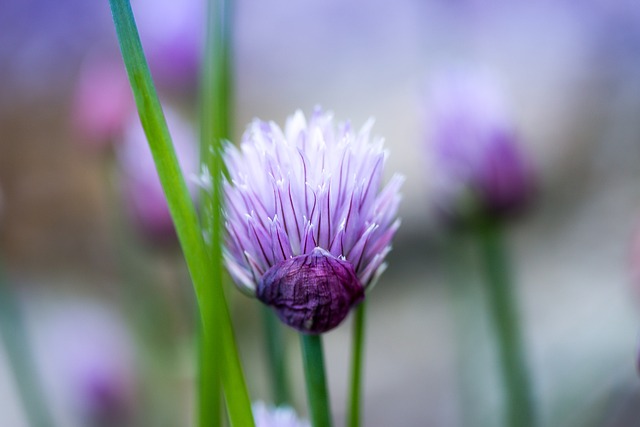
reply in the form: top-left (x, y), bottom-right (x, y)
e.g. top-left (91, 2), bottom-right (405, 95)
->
top-left (300, 334), bottom-right (331, 427)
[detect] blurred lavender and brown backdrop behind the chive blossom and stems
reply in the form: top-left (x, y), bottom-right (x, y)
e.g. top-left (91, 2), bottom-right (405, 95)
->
top-left (0, 0), bottom-right (640, 427)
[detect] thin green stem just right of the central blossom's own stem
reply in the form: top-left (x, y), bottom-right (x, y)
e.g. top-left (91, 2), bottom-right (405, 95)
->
top-left (347, 301), bottom-right (366, 427)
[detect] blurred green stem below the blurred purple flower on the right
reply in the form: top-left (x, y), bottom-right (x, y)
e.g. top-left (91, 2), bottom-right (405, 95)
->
top-left (477, 222), bottom-right (536, 427)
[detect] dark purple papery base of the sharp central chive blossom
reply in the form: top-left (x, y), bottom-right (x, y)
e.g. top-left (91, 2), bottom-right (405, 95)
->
top-left (256, 248), bottom-right (364, 334)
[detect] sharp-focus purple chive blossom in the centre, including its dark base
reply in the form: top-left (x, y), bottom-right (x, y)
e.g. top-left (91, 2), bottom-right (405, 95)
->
top-left (225, 110), bottom-right (402, 334)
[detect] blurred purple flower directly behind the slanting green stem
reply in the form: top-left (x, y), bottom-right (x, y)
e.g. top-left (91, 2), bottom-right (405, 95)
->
top-left (116, 107), bottom-right (199, 240)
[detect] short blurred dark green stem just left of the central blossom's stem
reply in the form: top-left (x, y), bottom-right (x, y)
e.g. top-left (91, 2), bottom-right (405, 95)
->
top-left (261, 304), bottom-right (292, 405)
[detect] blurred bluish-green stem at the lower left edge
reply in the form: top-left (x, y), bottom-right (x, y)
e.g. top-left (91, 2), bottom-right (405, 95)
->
top-left (0, 264), bottom-right (55, 427)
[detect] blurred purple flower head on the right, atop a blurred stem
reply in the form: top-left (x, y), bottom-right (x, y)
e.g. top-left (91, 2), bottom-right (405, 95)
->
top-left (427, 70), bottom-right (534, 221)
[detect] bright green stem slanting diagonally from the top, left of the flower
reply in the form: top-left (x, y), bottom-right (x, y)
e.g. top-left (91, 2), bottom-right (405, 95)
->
top-left (109, 0), bottom-right (254, 427)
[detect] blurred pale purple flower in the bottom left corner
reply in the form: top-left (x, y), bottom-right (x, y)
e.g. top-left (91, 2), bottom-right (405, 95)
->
top-left (36, 301), bottom-right (137, 425)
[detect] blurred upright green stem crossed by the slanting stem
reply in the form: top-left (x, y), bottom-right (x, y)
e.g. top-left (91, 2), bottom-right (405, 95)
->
top-left (199, 0), bottom-right (233, 427)
